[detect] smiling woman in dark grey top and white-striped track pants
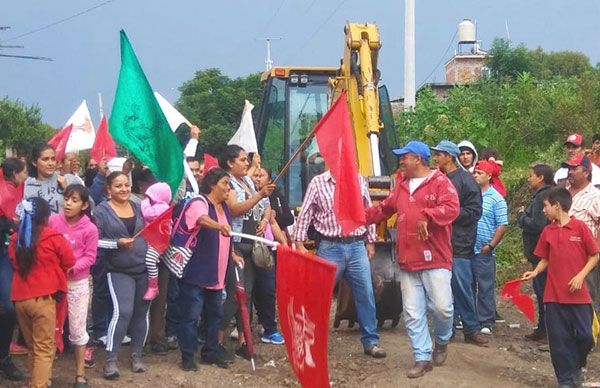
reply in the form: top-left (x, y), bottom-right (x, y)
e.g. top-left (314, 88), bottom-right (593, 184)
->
top-left (94, 171), bottom-right (150, 380)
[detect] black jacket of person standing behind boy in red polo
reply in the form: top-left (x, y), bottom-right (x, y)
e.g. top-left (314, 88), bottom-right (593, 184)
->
top-left (517, 186), bottom-right (552, 264)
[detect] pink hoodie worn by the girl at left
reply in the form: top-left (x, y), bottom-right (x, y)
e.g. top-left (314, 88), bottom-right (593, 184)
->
top-left (48, 212), bottom-right (98, 281)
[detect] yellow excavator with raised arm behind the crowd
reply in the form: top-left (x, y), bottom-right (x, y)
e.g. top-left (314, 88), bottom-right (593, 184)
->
top-left (256, 23), bottom-right (402, 327)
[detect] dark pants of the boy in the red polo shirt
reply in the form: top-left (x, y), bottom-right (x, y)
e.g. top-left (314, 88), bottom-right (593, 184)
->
top-left (544, 303), bottom-right (594, 386)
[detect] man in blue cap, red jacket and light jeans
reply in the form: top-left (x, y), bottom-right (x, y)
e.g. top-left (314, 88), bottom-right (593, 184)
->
top-left (366, 141), bottom-right (459, 378)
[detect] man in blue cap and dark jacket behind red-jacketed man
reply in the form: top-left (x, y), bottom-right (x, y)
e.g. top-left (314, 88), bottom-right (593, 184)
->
top-left (431, 140), bottom-right (488, 346)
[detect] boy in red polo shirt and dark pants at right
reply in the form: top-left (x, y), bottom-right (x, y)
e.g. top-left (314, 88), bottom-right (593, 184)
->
top-left (523, 187), bottom-right (599, 387)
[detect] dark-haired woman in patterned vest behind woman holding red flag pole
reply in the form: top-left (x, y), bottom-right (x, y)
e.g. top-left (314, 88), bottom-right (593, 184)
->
top-left (219, 145), bottom-right (283, 358)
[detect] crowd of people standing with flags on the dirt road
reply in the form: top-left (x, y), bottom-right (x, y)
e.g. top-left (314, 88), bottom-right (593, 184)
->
top-left (0, 127), bottom-right (600, 388)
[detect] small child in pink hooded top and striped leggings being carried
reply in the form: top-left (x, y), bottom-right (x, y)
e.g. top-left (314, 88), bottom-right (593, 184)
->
top-left (142, 182), bottom-right (171, 300)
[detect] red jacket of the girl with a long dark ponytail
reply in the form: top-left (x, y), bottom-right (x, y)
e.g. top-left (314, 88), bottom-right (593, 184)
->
top-left (8, 227), bottom-right (75, 302)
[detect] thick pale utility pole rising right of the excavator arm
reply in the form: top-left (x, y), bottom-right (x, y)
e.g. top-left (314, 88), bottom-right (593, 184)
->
top-left (404, 0), bottom-right (416, 110)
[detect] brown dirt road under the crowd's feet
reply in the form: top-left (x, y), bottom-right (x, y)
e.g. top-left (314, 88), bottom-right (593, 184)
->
top-left (0, 301), bottom-right (600, 388)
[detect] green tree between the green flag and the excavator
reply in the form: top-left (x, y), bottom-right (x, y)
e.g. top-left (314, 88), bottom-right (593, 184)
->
top-left (175, 68), bottom-right (262, 154)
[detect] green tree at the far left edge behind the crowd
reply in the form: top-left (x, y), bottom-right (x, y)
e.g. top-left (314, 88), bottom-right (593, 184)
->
top-left (0, 97), bottom-right (55, 153)
